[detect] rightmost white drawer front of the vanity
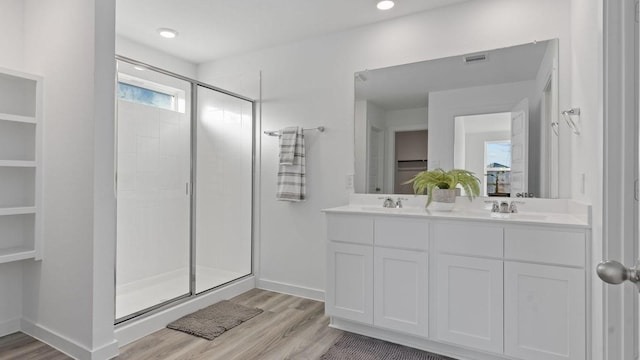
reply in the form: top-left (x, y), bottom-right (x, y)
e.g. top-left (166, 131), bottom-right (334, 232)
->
top-left (505, 228), bottom-right (586, 267)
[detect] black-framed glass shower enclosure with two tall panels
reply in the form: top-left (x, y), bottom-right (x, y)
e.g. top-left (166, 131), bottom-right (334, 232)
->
top-left (115, 58), bottom-right (255, 323)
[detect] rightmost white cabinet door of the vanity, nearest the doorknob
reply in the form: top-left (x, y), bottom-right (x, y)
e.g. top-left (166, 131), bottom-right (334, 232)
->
top-left (505, 262), bottom-right (586, 360)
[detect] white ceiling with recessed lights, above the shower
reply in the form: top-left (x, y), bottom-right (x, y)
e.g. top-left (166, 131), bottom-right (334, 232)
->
top-left (116, 0), bottom-right (471, 64)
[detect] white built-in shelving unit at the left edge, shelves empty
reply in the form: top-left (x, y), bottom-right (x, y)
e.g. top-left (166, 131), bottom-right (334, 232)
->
top-left (0, 68), bottom-right (42, 263)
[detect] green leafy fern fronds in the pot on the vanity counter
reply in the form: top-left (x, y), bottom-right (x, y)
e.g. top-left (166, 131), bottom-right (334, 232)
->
top-left (405, 169), bottom-right (480, 205)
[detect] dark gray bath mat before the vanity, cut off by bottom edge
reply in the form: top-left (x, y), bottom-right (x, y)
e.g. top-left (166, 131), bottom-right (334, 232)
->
top-left (320, 333), bottom-right (454, 360)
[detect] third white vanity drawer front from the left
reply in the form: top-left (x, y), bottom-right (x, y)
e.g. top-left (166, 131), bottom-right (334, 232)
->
top-left (434, 223), bottom-right (503, 257)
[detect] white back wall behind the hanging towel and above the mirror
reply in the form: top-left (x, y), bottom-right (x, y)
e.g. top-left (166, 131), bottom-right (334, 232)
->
top-left (198, 0), bottom-right (571, 297)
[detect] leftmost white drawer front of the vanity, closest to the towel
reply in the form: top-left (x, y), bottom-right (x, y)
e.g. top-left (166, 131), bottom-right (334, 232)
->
top-left (327, 214), bottom-right (373, 245)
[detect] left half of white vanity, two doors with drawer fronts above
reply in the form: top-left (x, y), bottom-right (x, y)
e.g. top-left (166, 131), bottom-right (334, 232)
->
top-left (325, 214), bottom-right (429, 337)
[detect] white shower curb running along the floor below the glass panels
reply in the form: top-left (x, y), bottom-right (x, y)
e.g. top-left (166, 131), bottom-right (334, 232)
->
top-left (115, 276), bottom-right (256, 346)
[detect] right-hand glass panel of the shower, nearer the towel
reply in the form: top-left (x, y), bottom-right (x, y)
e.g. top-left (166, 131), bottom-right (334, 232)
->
top-left (195, 87), bottom-right (253, 292)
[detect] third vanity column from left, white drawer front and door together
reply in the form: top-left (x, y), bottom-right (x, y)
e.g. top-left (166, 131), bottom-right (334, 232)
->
top-left (433, 222), bottom-right (504, 353)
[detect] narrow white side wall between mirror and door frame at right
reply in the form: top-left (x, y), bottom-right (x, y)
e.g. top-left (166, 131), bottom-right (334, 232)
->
top-left (560, 0), bottom-right (604, 359)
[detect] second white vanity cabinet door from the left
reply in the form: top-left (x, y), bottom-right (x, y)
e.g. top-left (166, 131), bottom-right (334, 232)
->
top-left (373, 247), bottom-right (429, 337)
